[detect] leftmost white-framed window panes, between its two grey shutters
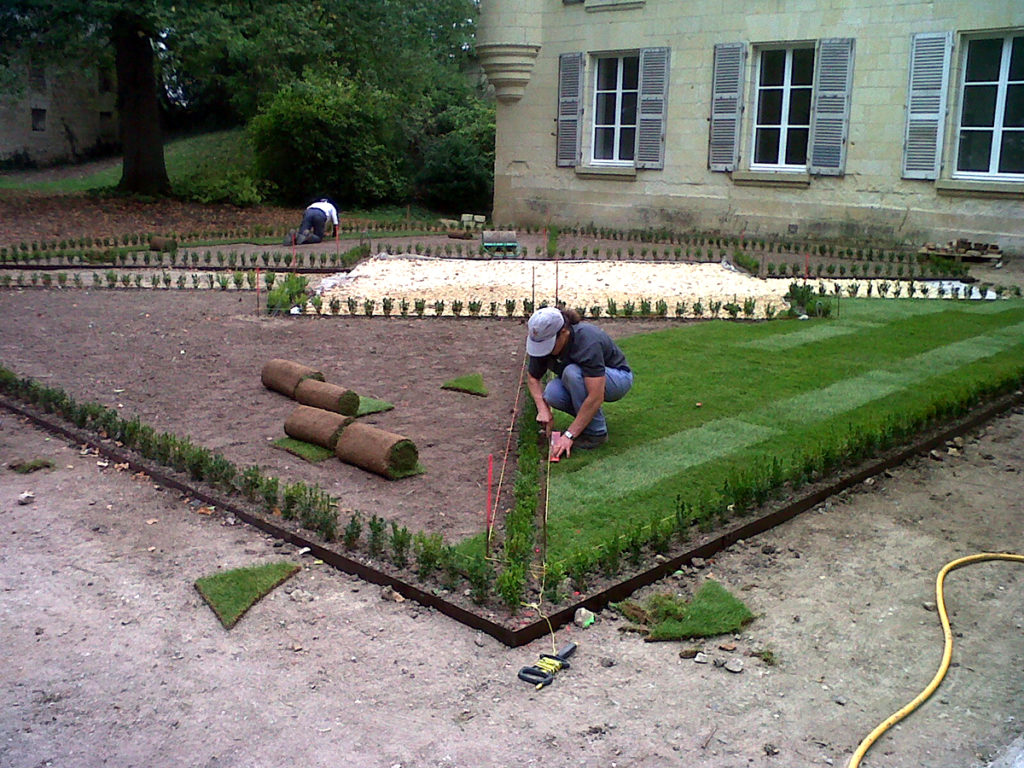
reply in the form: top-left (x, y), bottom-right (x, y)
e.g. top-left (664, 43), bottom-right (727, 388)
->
top-left (592, 55), bottom-right (640, 165)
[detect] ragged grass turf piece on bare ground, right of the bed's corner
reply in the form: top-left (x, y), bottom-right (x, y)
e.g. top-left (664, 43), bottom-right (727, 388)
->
top-left (611, 579), bottom-right (754, 642)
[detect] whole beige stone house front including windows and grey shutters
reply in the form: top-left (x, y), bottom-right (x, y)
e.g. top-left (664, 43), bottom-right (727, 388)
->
top-left (478, 0), bottom-right (1024, 252)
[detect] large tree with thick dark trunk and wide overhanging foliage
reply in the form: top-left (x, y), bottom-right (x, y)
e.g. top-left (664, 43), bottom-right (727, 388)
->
top-left (0, 0), bottom-right (475, 194)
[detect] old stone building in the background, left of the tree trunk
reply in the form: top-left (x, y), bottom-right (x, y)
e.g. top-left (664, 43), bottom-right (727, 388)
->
top-left (0, 65), bottom-right (118, 165)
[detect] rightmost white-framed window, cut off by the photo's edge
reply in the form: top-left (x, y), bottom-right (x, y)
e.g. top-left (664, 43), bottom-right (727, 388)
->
top-left (954, 32), bottom-right (1024, 180)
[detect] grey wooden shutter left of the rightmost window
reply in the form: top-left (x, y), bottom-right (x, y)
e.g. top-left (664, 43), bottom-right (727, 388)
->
top-left (903, 32), bottom-right (953, 179)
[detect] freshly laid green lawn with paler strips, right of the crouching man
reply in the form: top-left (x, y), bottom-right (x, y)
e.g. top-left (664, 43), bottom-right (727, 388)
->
top-left (548, 299), bottom-right (1024, 562)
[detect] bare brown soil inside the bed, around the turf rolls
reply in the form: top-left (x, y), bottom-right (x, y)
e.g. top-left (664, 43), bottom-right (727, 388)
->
top-left (0, 291), bottom-right (561, 539)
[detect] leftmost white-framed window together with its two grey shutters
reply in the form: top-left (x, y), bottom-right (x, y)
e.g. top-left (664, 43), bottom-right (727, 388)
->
top-left (555, 48), bottom-right (669, 173)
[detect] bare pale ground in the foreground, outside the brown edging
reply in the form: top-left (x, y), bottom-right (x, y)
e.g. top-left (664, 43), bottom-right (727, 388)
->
top-left (0, 393), bottom-right (1024, 768)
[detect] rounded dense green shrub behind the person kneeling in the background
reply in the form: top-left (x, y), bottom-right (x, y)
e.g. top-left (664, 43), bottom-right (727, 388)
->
top-left (249, 77), bottom-right (409, 206)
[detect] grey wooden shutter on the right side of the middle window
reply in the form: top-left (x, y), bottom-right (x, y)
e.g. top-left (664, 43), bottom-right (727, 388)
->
top-left (808, 38), bottom-right (853, 176)
